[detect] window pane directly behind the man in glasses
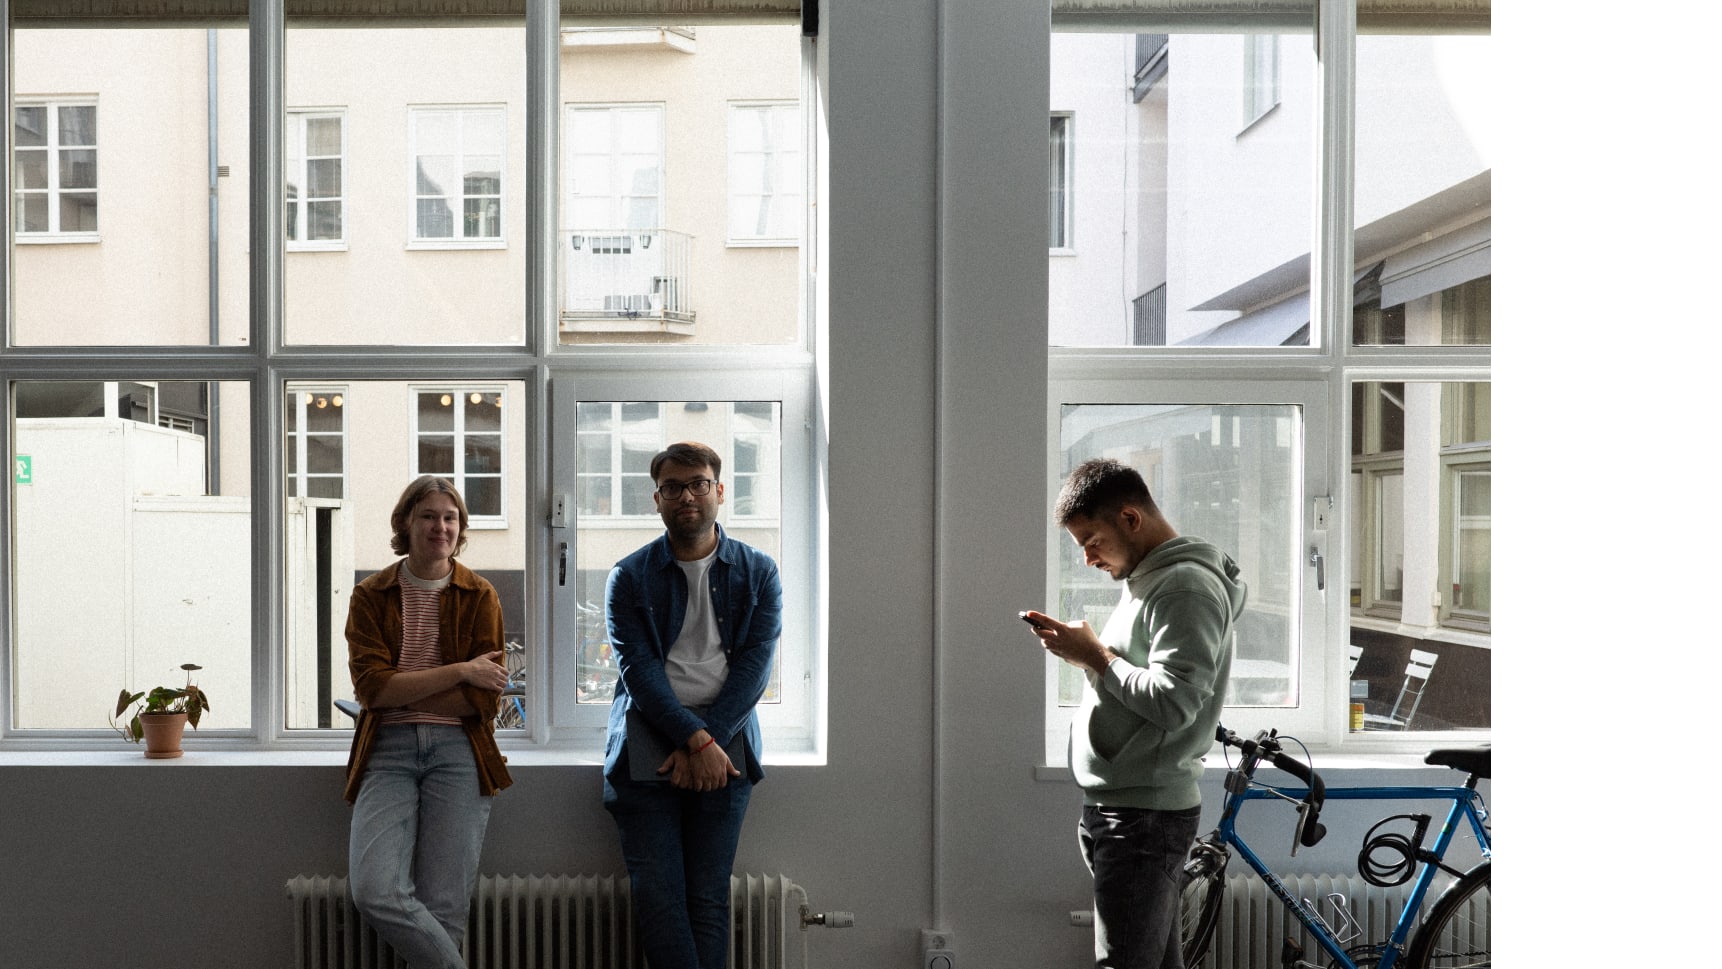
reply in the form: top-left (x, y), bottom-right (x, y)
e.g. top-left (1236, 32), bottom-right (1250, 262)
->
top-left (573, 399), bottom-right (784, 704)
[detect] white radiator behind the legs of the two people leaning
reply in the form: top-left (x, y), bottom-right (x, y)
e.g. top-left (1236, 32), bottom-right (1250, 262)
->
top-left (288, 874), bottom-right (808, 969)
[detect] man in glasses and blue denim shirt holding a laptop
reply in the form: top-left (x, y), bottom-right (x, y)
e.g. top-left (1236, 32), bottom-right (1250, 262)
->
top-left (604, 442), bottom-right (784, 969)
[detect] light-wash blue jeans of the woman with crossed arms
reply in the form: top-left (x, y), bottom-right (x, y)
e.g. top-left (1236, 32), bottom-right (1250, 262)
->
top-left (346, 723), bottom-right (491, 969)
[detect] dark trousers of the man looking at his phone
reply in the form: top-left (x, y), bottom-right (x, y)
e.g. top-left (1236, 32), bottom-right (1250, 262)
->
top-left (1076, 804), bottom-right (1202, 969)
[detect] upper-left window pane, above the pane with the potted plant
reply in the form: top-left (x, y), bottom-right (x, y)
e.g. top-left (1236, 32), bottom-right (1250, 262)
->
top-left (10, 26), bottom-right (250, 349)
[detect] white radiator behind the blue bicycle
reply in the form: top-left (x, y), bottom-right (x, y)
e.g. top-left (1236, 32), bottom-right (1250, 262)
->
top-left (1202, 874), bottom-right (1490, 969)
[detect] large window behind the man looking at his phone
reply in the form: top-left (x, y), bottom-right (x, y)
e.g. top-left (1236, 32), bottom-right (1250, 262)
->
top-left (1047, 11), bottom-right (1493, 746)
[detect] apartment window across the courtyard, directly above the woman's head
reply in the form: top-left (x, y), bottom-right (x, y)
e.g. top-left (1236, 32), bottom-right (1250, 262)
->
top-left (412, 384), bottom-right (508, 528)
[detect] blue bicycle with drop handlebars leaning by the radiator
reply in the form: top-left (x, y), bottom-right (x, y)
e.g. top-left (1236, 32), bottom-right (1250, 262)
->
top-left (1183, 726), bottom-right (1491, 969)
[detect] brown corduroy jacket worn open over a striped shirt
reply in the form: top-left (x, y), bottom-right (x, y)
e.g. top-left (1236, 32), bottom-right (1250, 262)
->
top-left (346, 561), bottom-right (513, 802)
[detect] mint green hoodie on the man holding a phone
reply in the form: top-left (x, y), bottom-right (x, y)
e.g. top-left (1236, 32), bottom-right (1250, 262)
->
top-left (1071, 537), bottom-right (1248, 811)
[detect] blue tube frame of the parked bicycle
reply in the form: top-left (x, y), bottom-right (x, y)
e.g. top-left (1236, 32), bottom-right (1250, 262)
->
top-left (1219, 785), bottom-right (1490, 969)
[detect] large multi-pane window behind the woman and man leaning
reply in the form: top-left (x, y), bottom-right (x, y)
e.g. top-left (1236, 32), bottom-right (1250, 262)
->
top-left (0, 14), bottom-right (823, 761)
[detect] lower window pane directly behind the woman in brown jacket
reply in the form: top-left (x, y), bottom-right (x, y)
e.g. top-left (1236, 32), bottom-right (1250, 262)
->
top-left (284, 380), bottom-right (529, 730)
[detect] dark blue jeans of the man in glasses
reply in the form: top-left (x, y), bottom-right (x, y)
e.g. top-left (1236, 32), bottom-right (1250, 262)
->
top-left (604, 752), bottom-right (753, 969)
